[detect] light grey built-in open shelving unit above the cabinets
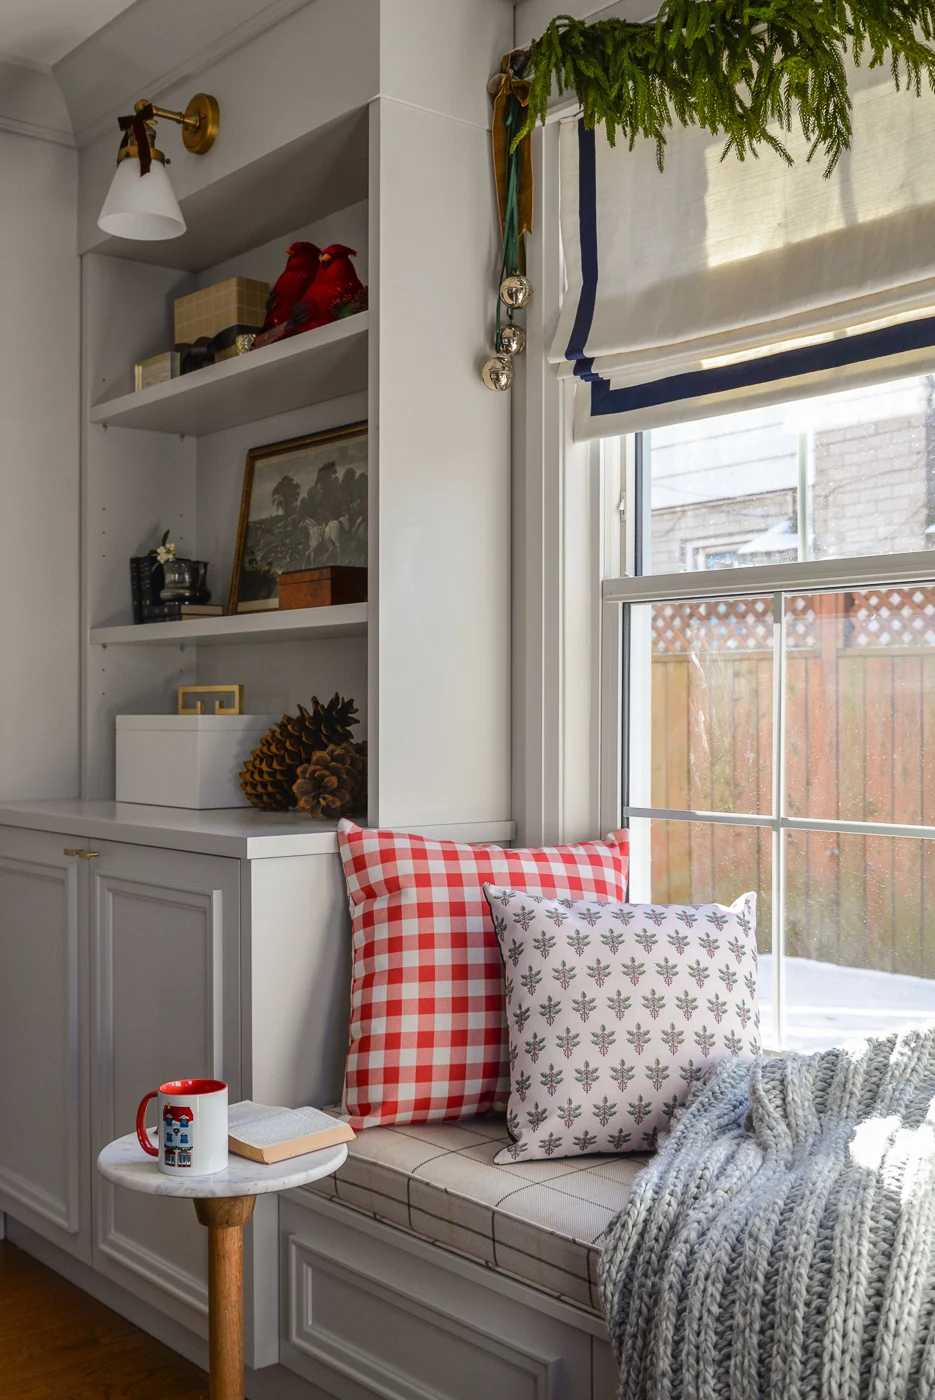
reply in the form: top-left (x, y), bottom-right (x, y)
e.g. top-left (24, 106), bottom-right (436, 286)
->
top-left (81, 46), bottom-right (511, 840)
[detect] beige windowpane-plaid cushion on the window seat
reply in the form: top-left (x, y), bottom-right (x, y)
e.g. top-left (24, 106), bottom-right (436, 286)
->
top-left (308, 1114), bottom-right (648, 1312)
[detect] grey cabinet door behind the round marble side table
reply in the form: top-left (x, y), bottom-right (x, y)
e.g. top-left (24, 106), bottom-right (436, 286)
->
top-left (91, 841), bottom-right (241, 1331)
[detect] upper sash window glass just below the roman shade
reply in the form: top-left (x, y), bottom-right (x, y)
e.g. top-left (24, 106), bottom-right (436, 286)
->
top-left (642, 375), bottom-right (935, 574)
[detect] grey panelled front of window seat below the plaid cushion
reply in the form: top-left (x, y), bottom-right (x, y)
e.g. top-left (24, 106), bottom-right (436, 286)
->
top-left (280, 1191), bottom-right (590, 1400)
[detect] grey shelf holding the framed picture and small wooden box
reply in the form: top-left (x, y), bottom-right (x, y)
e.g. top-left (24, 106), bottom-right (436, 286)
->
top-left (88, 603), bottom-right (367, 647)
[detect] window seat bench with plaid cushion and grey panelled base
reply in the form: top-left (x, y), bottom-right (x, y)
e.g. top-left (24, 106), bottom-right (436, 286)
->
top-left (279, 1116), bottom-right (647, 1400)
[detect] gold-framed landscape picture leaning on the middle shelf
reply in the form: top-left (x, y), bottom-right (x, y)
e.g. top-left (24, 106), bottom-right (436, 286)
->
top-left (228, 423), bottom-right (368, 613)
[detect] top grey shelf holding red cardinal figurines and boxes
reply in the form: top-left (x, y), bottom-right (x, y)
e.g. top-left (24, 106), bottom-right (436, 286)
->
top-left (91, 311), bottom-right (370, 437)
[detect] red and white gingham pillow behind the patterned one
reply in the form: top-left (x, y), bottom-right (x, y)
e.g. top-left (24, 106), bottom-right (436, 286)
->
top-left (337, 822), bottom-right (630, 1128)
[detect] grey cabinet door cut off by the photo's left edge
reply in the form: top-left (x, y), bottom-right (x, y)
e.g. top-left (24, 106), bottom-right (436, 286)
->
top-left (0, 826), bottom-right (91, 1260)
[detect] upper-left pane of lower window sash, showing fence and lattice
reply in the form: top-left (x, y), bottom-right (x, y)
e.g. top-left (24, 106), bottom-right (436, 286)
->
top-left (643, 595), bottom-right (773, 813)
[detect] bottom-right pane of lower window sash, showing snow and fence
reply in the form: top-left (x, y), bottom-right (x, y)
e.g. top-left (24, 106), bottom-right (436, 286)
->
top-left (783, 832), bottom-right (935, 1050)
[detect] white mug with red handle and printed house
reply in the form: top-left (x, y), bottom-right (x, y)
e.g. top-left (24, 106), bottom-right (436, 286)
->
top-left (136, 1079), bottom-right (227, 1176)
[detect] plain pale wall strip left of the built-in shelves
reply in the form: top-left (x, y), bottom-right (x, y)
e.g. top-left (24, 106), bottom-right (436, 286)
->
top-left (0, 130), bottom-right (80, 801)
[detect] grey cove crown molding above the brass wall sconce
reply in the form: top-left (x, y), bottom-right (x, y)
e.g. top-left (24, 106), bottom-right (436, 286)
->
top-left (55, 0), bottom-right (314, 147)
